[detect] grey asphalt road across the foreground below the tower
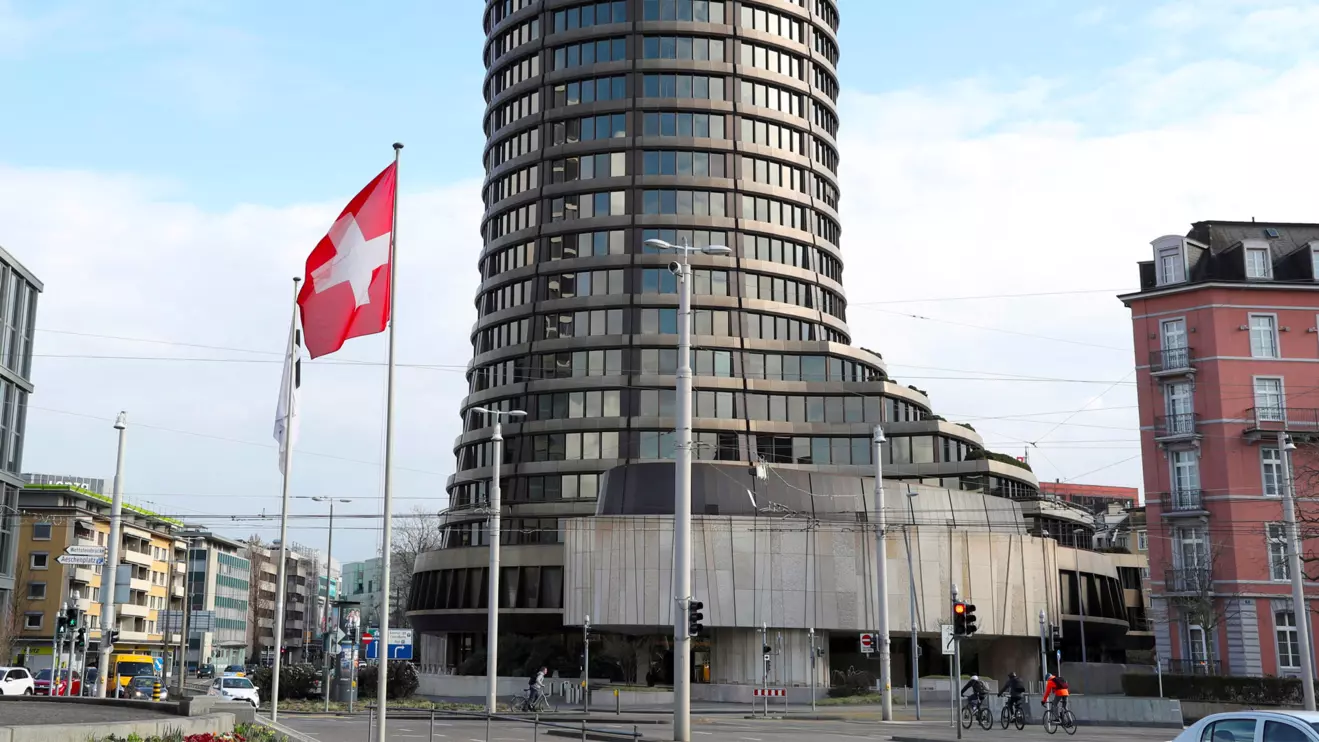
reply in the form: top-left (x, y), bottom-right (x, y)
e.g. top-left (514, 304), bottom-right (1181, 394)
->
top-left (280, 716), bottom-right (1177, 742)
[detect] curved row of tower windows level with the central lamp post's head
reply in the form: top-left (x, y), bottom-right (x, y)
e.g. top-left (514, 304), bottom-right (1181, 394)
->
top-left (483, 229), bottom-right (843, 281)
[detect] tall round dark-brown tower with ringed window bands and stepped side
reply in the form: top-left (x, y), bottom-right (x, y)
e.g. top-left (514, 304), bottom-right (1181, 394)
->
top-left (409, 0), bottom-right (1060, 680)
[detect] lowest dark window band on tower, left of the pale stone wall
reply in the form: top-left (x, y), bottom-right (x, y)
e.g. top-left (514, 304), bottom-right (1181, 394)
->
top-left (408, 566), bottom-right (563, 610)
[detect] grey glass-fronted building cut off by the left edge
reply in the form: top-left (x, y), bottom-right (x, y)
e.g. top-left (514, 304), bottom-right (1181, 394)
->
top-left (0, 248), bottom-right (42, 623)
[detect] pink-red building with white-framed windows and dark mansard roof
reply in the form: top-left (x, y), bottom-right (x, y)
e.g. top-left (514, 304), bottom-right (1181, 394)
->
top-left (1121, 220), bottom-right (1319, 675)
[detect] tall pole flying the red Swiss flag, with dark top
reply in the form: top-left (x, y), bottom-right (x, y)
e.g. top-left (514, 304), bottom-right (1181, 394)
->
top-left (376, 142), bottom-right (404, 742)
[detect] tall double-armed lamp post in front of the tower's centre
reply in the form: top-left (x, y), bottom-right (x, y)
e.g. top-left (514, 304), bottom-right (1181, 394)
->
top-left (645, 240), bottom-right (732, 742)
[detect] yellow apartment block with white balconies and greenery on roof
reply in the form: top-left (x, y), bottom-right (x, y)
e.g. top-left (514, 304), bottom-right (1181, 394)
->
top-left (13, 485), bottom-right (186, 667)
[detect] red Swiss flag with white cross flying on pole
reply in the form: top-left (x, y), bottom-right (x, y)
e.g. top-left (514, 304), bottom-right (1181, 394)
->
top-left (298, 163), bottom-right (397, 358)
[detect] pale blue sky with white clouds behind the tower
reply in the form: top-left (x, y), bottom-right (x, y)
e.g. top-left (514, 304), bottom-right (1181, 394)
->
top-left (0, 0), bottom-right (1319, 560)
